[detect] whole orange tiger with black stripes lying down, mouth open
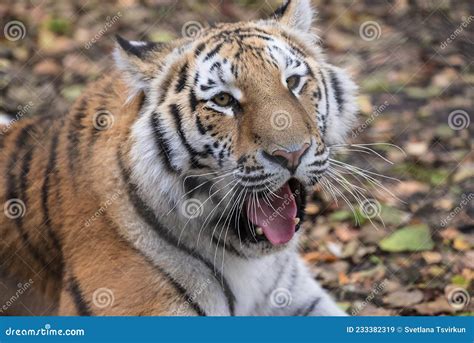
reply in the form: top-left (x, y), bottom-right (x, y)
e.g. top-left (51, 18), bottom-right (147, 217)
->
top-left (0, 0), bottom-right (358, 316)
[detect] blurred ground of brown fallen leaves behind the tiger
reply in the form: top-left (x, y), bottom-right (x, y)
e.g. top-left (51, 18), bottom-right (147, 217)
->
top-left (0, 0), bottom-right (474, 315)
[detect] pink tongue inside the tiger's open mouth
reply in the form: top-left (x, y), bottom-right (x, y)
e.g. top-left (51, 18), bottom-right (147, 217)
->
top-left (246, 183), bottom-right (296, 245)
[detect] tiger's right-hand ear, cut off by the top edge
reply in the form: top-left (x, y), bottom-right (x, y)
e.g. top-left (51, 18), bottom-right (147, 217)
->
top-left (273, 0), bottom-right (316, 32)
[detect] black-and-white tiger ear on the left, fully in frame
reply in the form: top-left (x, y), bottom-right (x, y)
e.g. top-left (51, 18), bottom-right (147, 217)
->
top-left (114, 35), bottom-right (172, 91)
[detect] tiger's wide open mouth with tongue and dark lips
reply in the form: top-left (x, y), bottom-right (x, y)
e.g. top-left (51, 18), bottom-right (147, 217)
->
top-left (239, 178), bottom-right (306, 245)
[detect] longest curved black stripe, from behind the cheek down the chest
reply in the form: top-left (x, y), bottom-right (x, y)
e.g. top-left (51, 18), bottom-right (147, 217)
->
top-left (117, 150), bottom-right (235, 316)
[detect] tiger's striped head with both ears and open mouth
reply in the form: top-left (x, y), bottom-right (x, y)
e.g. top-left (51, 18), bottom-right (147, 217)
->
top-left (115, 0), bottom-right (357, 252)
